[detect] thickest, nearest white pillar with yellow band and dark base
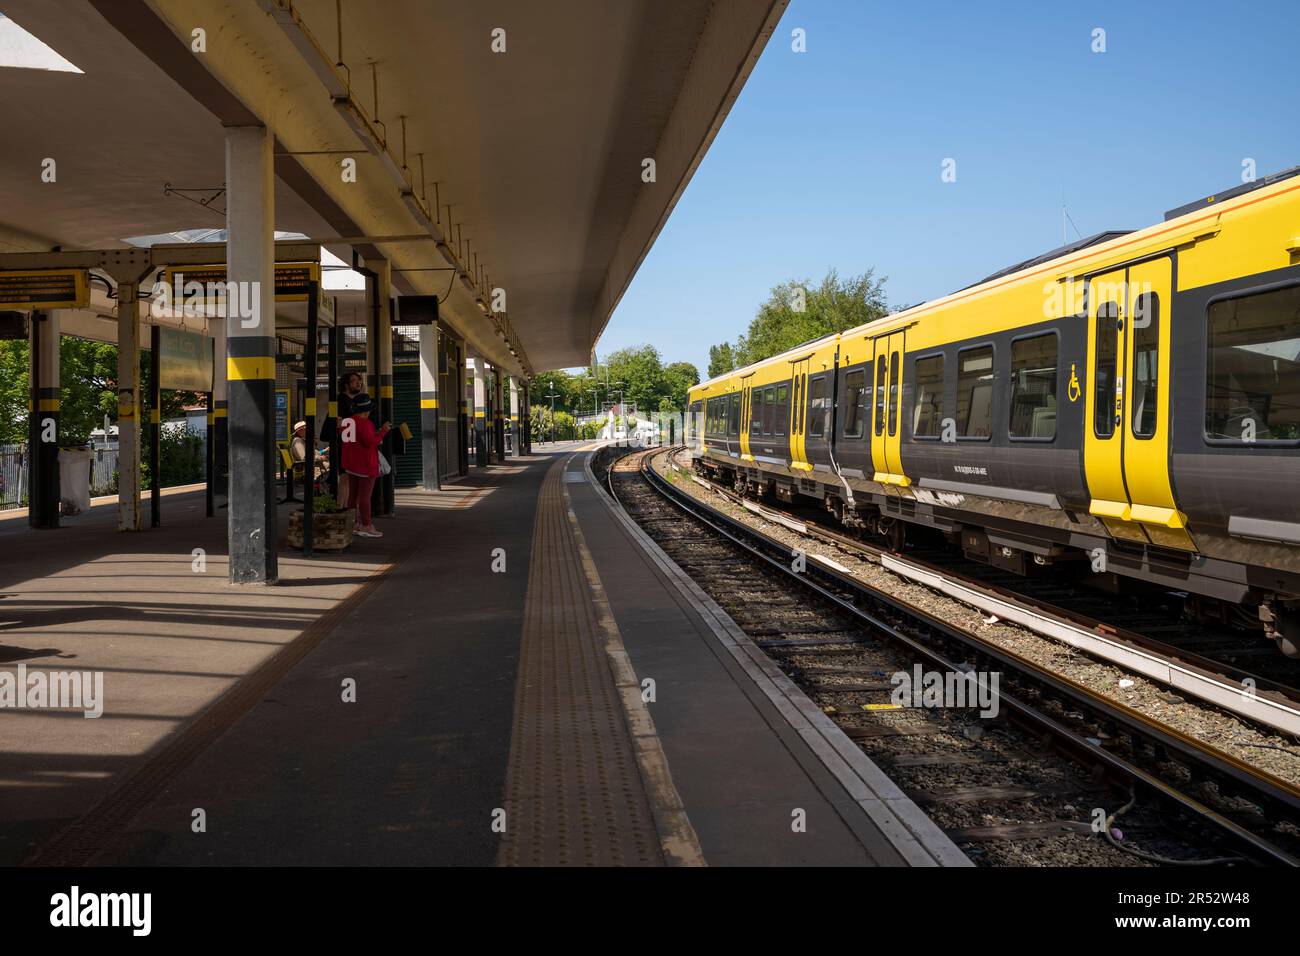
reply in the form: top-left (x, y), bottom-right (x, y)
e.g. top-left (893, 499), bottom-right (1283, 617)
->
top-left (226, 126), bottom-right (280, 584)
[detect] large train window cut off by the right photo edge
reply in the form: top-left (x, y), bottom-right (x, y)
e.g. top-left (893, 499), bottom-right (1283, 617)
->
top-left (1205, 285), bottom-right (1300, 444)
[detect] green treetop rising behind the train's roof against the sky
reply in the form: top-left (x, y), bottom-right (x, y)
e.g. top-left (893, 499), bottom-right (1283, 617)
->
top-left (709, 269), bottom-right (889, 376)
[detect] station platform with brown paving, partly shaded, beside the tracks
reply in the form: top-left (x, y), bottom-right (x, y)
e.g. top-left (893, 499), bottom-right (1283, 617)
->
top-left (0, 445), bottom-right (967, 866)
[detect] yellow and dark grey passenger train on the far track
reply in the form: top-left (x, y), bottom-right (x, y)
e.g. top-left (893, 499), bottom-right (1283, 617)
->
top-left (686, 166), bottom-right (1300, 656)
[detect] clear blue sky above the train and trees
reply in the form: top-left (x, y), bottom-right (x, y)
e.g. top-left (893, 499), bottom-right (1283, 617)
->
top-left (597, 0), bottom-right (1300, 373)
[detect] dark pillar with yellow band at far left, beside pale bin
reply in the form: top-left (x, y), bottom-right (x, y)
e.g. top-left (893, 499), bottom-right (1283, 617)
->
top-left (27, 311), bottom-right (60, 528)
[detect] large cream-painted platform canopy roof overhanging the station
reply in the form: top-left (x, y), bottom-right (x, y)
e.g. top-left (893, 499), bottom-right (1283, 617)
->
top-left (0, 0), bottom-right (787, 376)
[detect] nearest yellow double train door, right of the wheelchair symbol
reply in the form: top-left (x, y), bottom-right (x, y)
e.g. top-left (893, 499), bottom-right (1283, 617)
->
top-left (1083, 258), bottom-right (1195, 550)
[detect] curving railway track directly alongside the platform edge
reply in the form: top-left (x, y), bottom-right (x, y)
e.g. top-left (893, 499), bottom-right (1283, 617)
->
top-left (608, 450), bottom-right (1300, 865)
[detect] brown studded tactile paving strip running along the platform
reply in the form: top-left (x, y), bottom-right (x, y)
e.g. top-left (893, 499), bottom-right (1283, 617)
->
top-left (498, 459), bottom-right (664, 866)
